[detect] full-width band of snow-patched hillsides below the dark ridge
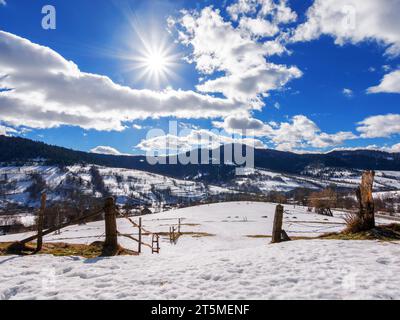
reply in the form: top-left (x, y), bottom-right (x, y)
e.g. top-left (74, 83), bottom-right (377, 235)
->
top-left (0, 165), bottom-right (400, 211)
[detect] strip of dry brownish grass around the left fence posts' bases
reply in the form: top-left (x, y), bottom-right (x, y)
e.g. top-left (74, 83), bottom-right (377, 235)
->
top-left (0, 241), bottom-right (138, 258)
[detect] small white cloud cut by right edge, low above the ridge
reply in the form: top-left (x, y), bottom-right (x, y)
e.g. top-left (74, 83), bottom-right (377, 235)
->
top-left (357, 114), bottom-right (400, 138)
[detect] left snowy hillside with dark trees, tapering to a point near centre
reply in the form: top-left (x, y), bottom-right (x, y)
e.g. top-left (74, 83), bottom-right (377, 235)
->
top-left (0, 165), bottom-right (228, 206)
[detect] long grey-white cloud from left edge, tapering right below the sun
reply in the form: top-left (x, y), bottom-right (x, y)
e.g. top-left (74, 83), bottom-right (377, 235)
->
top-left (0, 31), bottom-right (248, 130)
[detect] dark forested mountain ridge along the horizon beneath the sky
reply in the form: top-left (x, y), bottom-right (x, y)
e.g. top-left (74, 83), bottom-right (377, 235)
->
top-left (0, 136), bottom-right (400, 182)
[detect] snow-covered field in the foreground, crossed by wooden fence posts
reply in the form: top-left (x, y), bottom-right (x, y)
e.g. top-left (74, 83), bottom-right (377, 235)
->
top-left (0, 202), bottom-right (400, 299)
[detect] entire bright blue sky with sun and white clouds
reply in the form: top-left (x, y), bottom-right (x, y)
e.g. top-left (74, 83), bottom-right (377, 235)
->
top-left (0, 0), bottom-right (400, 154)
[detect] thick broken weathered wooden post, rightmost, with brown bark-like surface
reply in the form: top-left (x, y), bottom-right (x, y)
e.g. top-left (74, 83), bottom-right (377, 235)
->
top-left (356, 171), bottom-right (375, 231)
